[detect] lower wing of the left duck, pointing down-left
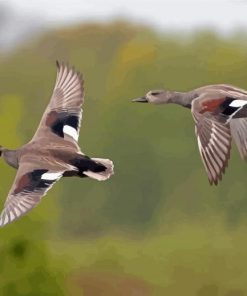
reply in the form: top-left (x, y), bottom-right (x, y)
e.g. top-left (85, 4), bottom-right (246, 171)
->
top-left (0, 157), bottom-right (65, 227)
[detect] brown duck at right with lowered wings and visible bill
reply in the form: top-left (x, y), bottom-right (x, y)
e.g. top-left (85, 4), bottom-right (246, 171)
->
top-left (132, 84), bottom-right (247, 185)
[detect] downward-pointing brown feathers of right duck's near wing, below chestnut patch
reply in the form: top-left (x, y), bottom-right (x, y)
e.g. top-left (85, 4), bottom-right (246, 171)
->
top-left (192, 100), bottom-right (231, 185)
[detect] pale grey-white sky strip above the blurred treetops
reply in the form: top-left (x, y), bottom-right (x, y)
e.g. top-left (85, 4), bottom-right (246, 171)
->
top-left (0, 0), bottom-right (247, 48)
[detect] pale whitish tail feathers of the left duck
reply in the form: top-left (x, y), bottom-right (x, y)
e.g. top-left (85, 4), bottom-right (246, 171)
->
top-left (83, 158), bottom-right (114, 181)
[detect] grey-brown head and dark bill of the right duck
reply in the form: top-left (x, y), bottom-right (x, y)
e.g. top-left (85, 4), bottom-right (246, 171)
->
top-left (132, 90), bottom-right (173, 104)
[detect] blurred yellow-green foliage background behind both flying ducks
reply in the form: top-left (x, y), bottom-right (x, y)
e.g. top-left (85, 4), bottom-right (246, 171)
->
top-left (0, 22), bottom-right (247, 296)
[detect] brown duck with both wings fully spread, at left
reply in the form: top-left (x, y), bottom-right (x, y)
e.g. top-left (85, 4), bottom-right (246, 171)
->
top-left (0, 62), bottom-right (113, 226)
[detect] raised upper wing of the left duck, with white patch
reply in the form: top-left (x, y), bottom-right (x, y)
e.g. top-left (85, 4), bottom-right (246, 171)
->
top-left (33, 62), bottom-right (84, 143)
